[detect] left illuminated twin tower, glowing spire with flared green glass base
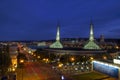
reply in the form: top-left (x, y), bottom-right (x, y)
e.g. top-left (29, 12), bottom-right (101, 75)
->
top-left (50, 25), bottom-right (63, 48)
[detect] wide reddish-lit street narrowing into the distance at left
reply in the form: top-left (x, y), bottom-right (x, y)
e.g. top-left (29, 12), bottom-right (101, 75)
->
top-left (16, 44), bottom-right (71, 80)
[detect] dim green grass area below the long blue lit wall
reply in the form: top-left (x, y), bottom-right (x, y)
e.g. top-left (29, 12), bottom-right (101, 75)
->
top-left (71, 72), bottom-right (108, 80)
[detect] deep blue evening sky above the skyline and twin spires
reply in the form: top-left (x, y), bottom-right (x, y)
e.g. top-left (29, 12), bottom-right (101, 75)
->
top-left (0, 0), bottom-right (120, 40)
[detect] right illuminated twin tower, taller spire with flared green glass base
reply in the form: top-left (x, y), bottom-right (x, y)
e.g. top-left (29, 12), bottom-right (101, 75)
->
top-left (83, 22), bottom-right (101, 50)
